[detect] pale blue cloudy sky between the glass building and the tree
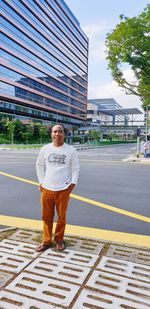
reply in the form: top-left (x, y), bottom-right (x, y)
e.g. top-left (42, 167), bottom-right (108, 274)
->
top-left (65, 0), bottom-right (149, 110)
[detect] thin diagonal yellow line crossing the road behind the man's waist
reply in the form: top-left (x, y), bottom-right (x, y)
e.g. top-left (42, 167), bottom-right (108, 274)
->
top-left (0, 172), bottom-right (150, 223)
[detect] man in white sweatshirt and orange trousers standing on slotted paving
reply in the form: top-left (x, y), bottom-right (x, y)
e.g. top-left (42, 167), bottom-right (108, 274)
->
top-left (36, 124), bottom-right (79, 252)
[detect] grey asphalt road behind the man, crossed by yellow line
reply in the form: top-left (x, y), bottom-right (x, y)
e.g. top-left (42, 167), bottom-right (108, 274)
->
top-left (0, 144), bottom-right (150, 235)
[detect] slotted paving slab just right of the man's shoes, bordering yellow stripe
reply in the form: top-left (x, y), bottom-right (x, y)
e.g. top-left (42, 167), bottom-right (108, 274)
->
top-left (65, 236), bottom-right (104, 254)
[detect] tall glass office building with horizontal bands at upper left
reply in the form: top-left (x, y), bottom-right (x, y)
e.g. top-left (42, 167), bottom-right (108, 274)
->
top-left (0, 0), bottom-right (88, 126)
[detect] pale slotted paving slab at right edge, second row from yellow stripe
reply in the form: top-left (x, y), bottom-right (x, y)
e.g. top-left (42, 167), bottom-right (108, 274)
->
top-left (96, 256), bottom-right (150, 284)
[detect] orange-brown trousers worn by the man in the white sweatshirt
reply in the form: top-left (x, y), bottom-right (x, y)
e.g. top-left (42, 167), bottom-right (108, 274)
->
top-left (41, 188), bottom-right (70, 244)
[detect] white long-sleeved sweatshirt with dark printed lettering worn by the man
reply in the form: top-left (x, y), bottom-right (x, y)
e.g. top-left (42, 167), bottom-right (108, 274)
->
top-left (36, 143), bottom-right (79, 191)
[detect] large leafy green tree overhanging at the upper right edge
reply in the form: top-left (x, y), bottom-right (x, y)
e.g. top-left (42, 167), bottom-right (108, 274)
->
top-left (106, 4), bottom-right (150, 107)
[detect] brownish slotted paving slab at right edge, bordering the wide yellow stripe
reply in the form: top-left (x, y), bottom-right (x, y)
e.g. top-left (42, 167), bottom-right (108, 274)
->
top-left (106, 245), bottom-right (150, 265)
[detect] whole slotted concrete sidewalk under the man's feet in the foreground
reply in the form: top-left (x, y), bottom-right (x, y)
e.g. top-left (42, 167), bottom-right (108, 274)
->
top-left (0, 229), bottom-right (150, 309)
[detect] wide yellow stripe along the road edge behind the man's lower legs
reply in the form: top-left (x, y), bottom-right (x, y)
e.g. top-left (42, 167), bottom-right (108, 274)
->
top-left (0, 216), bottom-right (150, 248)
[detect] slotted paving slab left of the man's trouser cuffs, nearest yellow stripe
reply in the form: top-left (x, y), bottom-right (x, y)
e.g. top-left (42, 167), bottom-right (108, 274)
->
top-left (8, 230), bottom-right (41, 244)
